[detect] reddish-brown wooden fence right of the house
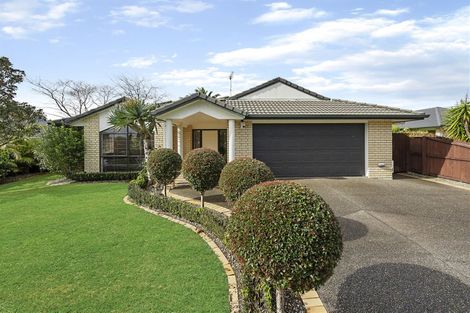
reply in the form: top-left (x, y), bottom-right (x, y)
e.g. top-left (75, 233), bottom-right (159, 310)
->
top-left (393, 134), bottom-right (470, 183)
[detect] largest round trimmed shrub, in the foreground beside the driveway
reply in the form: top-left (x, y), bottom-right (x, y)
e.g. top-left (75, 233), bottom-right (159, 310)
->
top-left (227, 181), bottom-right (343, 292)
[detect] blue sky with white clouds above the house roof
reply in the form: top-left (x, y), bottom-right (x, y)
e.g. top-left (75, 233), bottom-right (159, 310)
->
top-left (0, 0), bottom-right (470, 114)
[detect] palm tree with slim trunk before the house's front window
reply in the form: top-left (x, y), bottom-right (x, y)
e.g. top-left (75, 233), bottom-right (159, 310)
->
top-left (108, 99), bottom-right (159, 177)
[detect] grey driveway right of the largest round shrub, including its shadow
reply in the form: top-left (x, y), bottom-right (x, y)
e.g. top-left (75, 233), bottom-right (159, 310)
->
top-left (297, 176), bottom-right (470, 313)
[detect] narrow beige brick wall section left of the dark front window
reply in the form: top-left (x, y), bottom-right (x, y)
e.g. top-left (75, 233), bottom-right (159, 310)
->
top-left (83, 114), bottom-right (100, 172)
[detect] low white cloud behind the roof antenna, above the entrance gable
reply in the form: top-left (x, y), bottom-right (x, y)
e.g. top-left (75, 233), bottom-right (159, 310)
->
top-left (155, 67), bottom-right (265, 95)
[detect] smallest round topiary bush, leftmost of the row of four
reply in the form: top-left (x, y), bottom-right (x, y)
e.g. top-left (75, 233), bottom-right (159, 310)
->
top-left (147, 148), bottom-right (182, 196)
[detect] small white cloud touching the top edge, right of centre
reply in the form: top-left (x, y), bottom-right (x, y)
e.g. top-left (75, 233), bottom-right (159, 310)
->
top-left (253, 2), bottom-right (326, 24)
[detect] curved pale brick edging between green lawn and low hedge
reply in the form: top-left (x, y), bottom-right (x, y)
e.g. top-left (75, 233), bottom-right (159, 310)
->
top-left (123, 195), bottom-right (240, 313)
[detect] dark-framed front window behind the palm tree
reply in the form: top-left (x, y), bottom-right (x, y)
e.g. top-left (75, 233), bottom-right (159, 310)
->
top-left (100, 127), bottom-right (154, 172)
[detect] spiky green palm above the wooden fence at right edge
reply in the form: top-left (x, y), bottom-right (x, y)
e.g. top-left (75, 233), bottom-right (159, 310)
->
top-left (445, 96), bottom-right (470, 141)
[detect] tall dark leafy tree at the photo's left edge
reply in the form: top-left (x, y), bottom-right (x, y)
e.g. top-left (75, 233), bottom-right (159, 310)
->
top-left (0, 57), bottom-right (44, 147)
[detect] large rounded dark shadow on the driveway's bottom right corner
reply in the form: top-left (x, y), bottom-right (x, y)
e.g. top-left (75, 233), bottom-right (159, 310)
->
top-left (337, 263), bottom-right (470, 313)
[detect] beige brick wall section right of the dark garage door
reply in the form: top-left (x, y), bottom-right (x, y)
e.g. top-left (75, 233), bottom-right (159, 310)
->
top-left (367, 121), bottom-right (393, 179)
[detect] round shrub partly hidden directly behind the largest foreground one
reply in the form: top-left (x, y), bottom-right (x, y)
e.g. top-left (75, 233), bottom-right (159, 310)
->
top-left (219, 158), bottom-right (274, 201)
